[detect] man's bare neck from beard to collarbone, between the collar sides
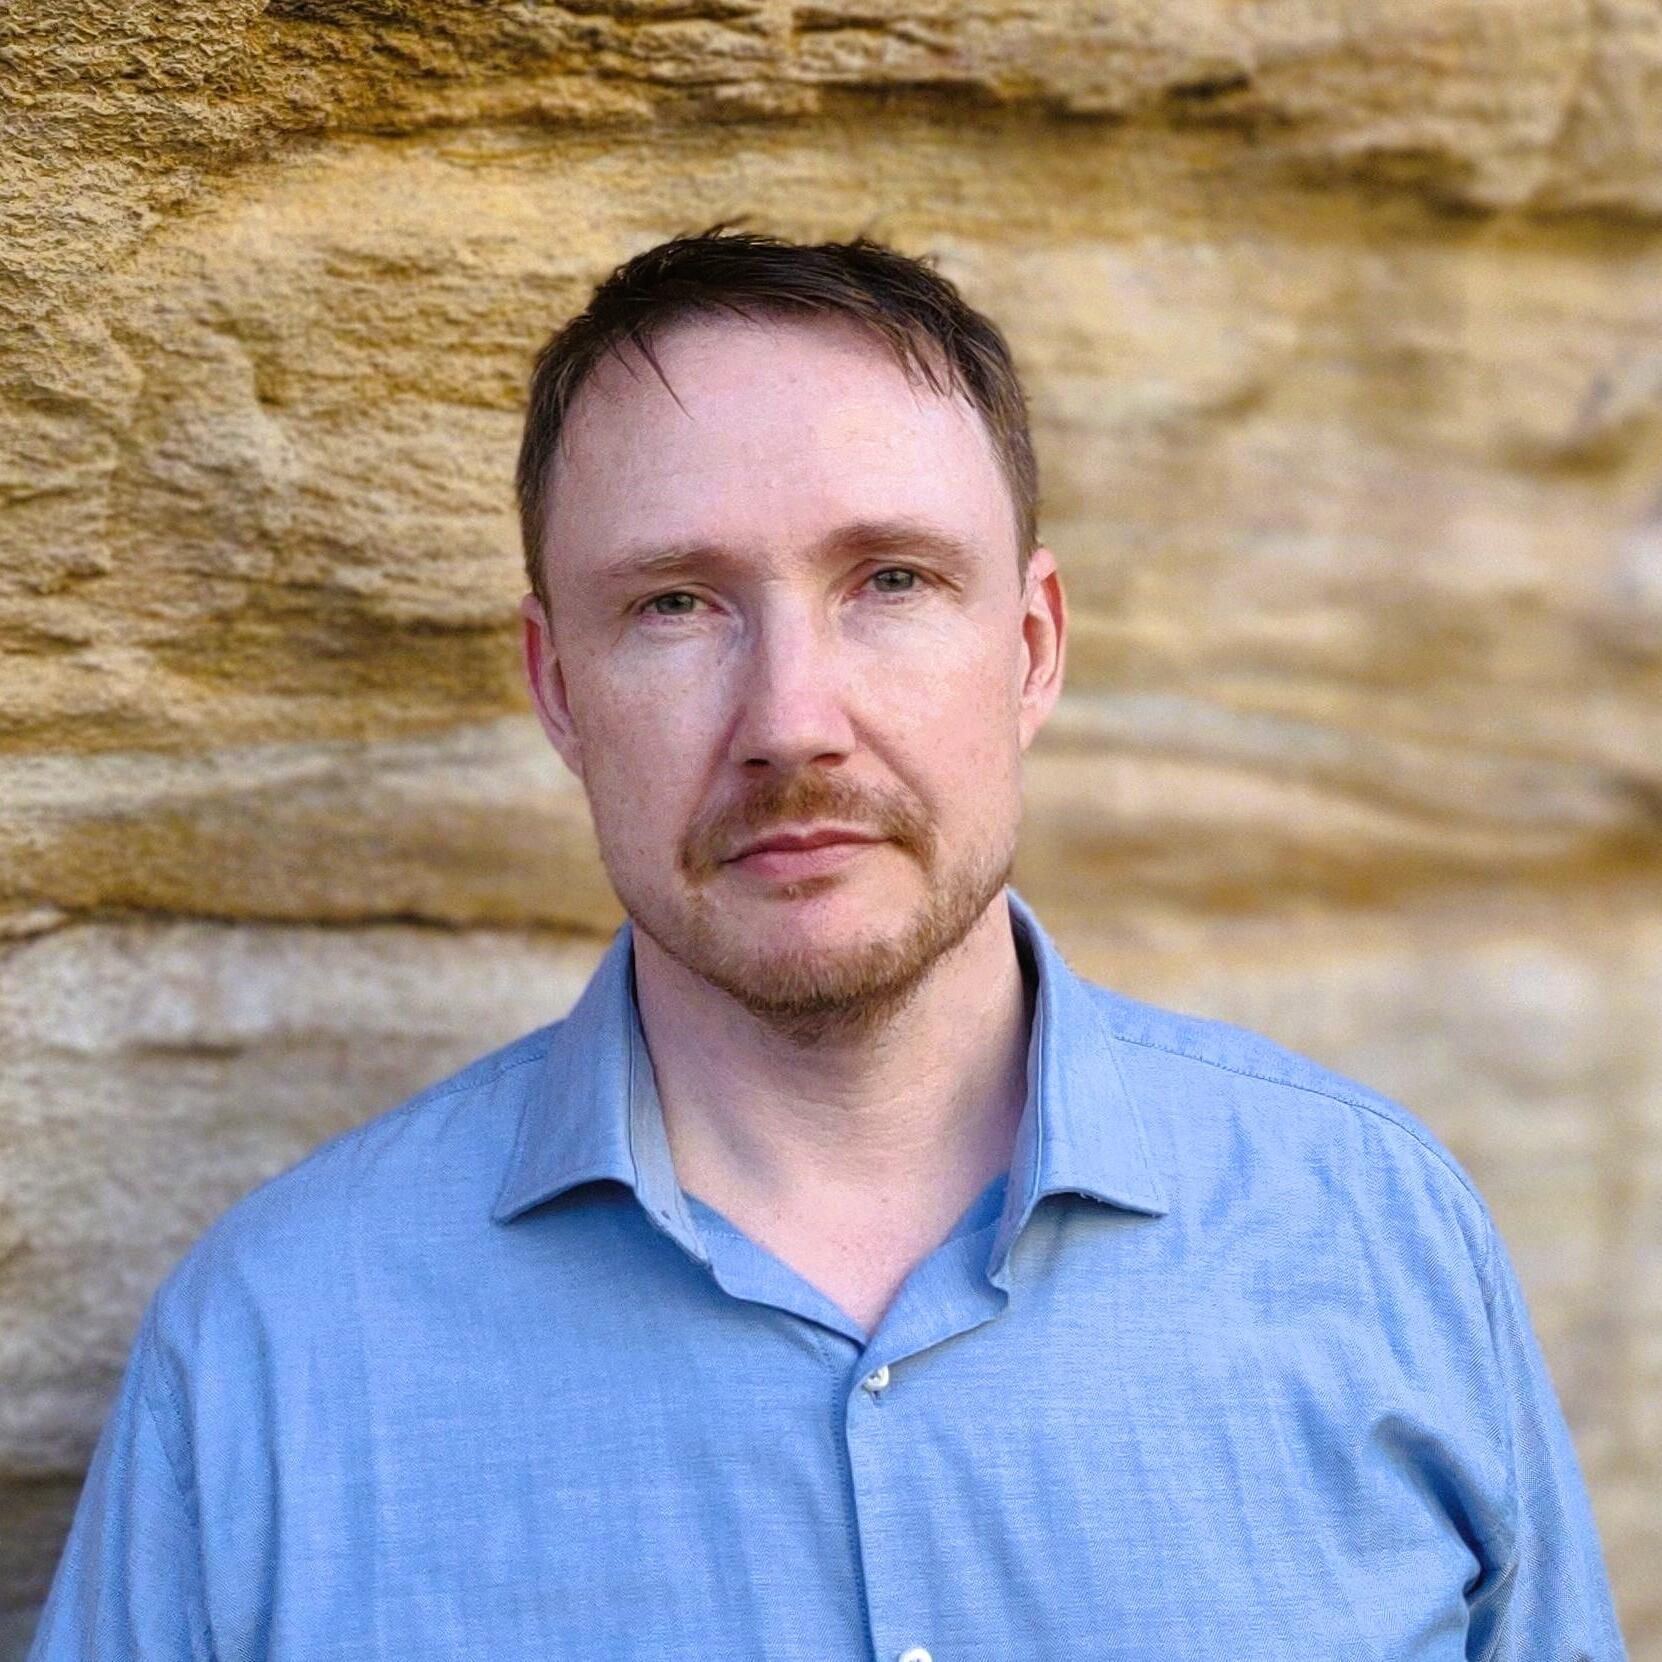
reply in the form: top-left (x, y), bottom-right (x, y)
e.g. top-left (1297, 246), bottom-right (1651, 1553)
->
top-left (635, 891), bottom-right (1030, 1233)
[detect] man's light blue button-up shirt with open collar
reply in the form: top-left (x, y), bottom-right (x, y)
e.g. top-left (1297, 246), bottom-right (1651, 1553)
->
top-left (32, 892), bottom-right (1624, 1662)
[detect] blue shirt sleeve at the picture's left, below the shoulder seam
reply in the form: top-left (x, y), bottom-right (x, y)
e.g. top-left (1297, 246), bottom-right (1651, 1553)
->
top-left (27, 1310), bottom-right (213, 1662)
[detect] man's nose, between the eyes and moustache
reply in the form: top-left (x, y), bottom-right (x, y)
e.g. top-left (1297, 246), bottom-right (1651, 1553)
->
top-left (730, 605), bottom-right (854, 774)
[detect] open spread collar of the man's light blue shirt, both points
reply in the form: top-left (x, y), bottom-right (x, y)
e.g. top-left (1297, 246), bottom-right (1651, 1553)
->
top-left (492, 889), bottom-right (1168, 1249)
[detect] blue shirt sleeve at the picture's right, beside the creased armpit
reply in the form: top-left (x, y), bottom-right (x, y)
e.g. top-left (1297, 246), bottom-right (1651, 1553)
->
top-left (1466, 1218), bottom-right (1627, 1662)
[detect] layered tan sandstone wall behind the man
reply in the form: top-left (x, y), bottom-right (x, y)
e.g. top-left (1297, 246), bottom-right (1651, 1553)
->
top-left (0, 0), bottom-right (1662, 1662)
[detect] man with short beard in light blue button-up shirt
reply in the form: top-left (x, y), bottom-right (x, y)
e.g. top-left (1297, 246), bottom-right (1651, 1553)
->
top-left (35, 233), bottom-right (1622, 1662)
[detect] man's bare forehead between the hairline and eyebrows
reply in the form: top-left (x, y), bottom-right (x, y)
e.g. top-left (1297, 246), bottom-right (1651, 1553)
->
top-left (547, 317), bottom-right (1015, 580)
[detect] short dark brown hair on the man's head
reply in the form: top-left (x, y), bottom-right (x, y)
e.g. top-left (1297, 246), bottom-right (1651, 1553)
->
top-left (515, 224), bottom-right (1039, 608)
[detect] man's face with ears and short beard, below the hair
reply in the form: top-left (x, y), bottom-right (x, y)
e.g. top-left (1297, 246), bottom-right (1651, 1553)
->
top-left (525, 319), bottom-right (1064, 1035)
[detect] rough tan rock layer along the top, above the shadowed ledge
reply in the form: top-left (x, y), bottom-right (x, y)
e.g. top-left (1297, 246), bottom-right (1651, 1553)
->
top-left (0, 0), bottom-right (1662, 234)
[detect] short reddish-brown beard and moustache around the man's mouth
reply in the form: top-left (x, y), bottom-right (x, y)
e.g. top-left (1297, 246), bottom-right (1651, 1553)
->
top-left (602, 773), bottom-right (1015, 1047)
